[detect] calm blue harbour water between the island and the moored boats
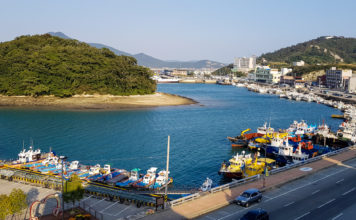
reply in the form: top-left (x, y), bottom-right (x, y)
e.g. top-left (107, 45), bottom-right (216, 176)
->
top-left (0, 84), bottom-right (340, 186)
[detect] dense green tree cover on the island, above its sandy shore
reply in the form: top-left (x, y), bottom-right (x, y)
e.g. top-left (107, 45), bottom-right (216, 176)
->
top-left (0, 34), bottom-right (156, 97)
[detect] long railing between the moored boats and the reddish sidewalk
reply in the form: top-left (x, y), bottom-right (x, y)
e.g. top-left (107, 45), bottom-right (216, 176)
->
top-left (169, 146), bottom-right (356, 207)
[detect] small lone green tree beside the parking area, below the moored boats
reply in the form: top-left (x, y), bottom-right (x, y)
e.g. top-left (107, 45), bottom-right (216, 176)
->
top-left (63, 174), bottom-right (84, 207)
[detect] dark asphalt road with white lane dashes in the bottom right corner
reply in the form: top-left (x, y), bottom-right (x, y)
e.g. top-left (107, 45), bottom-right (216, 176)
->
top-left (198, 159), bottom-right (356, 220)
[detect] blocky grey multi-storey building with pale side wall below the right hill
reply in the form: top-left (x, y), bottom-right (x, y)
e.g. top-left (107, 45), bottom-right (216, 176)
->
top-left (325, 67), bottom-right (352, 90)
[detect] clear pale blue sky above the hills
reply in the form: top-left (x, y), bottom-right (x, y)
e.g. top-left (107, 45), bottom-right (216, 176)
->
top-left (0, 0), bottom-right (356, 63)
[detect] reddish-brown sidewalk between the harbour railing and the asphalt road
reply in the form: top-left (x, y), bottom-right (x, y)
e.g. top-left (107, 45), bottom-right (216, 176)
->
top-left (145, 149), bottom-right (356, 219)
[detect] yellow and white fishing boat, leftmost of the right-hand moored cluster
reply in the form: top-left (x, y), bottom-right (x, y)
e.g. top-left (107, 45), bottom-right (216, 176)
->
top-left (218, 151), bottom-right (252, 179)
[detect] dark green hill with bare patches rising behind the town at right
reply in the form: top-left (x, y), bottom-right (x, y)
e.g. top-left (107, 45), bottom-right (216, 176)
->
top-left (258, 37), bottom-right (356, 64)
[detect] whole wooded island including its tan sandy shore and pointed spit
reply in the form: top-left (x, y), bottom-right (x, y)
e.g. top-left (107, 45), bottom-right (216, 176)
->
top-left (0, 34), bottom-right (196, 110)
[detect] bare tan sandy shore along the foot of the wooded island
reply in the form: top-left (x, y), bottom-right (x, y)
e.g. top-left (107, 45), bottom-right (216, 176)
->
top-left (0, 92), bottom-right (198, 111)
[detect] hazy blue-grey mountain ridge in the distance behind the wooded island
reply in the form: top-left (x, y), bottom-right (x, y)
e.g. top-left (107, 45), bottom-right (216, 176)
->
top-left (48, 32), bottom-right (225, 69)
